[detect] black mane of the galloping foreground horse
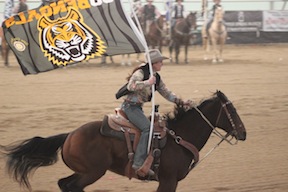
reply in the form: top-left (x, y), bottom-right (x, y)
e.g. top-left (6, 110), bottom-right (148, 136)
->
top-left (164, 91), bottom-right (218, 124)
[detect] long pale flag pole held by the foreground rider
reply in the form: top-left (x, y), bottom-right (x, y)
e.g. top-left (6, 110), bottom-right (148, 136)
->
top-left (129, 0), bottom-right (155, 154)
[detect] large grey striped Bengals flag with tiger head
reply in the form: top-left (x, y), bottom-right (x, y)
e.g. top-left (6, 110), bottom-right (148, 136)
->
top-left (2, 0), bottom-right (145, 75)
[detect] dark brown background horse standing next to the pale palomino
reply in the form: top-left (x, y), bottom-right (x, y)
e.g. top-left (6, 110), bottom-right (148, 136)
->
top-left (169, 12), bottom-right (197, 64)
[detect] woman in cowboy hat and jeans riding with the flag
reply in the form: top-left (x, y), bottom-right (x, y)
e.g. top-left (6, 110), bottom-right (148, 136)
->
top-left (121, 49), bottom-right (188, 175)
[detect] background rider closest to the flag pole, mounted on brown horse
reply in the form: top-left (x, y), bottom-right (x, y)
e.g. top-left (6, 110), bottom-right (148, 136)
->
top-left (141, 0), bottom-right (161, 34)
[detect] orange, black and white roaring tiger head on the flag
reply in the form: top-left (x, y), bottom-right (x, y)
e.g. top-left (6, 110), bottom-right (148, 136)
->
top-left (38, 8), bottom-right (106, 66)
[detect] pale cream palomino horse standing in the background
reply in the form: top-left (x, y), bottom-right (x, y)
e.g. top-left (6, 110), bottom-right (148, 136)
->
top-left (202, 7), bottom-right (227, 63)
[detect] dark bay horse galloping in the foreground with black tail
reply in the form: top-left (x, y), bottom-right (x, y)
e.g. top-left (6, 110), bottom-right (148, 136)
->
top-left (0, 91), bottom-right (246, 192)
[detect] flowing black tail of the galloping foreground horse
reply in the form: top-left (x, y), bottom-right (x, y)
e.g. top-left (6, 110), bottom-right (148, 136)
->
top-left (0, 133), bottom-right (68, 189)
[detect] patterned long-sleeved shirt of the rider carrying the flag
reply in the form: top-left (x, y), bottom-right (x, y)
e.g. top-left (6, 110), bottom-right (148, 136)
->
top-left (125, 69), bottom-right (177, 104)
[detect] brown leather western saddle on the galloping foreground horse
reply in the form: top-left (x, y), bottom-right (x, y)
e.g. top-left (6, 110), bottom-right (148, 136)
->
top-left (100, 108), bottom-right (166, 180)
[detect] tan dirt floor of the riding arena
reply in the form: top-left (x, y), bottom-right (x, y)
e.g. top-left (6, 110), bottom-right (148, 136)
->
top-left (0, 44), bottom-right (288, 192)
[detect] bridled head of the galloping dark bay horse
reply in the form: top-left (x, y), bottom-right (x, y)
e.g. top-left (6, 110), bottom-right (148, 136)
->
top-left (215, 91), bottom-right (246, 141)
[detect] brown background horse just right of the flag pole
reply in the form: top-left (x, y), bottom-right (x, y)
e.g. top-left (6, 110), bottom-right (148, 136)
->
top-left (145, 15), bottom-right (166, 51)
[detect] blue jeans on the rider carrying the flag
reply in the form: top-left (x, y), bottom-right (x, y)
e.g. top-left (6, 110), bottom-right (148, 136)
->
top-left (121, 101), bottom-right (150, 167)
